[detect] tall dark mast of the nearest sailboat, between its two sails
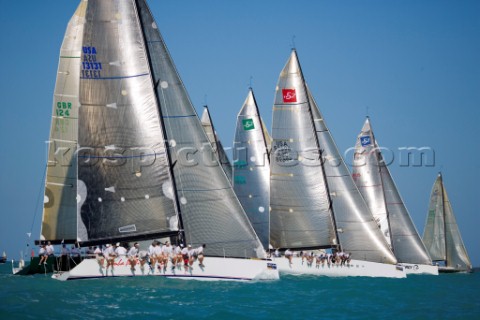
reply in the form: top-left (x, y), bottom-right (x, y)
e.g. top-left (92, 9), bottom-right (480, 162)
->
top-left (135, 0), bottom-right (185, 243)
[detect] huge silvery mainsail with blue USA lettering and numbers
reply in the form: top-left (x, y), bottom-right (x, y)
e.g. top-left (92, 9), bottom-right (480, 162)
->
top-left (78, 0), bottom-right (178, 241)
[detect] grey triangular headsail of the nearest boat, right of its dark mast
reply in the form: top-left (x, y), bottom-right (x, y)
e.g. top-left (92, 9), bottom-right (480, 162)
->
top-left (136, 1), bottom-right (264, 258)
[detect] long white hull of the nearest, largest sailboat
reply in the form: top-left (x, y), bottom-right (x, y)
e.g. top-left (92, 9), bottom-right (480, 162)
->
top-left (52, 257), bottom-right (279, 281)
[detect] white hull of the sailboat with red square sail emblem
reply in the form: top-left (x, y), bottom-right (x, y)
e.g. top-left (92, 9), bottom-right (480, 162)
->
top-left (273, 257), bottom-right (406, 278)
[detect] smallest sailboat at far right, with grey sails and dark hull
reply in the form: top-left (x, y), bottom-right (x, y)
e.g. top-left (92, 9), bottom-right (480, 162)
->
top-left (423, 173), bottom-right (472, 273)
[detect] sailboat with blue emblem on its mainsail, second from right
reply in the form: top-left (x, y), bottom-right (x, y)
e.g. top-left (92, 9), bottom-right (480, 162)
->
top-left (352, 117), bottom-right (438, 275)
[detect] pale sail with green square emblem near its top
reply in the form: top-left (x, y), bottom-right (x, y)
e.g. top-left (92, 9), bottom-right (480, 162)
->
top-left (233, 89), bottom-right (270, 249)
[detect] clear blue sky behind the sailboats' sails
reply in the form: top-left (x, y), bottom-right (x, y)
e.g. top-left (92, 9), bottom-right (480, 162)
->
top-left (0, 0), bottom-right (480, 266)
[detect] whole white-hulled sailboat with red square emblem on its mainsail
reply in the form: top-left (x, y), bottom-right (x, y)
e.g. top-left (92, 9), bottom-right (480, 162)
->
top-left (270, 49), bottom-right (406, 278)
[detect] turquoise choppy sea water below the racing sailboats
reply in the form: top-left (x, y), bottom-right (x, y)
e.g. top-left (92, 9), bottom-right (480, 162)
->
top-left (0, 263), bottom-right (480, 320)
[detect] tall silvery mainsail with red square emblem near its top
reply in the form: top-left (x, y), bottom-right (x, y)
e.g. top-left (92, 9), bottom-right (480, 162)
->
top-left (270, 50), bottom-right (337, 248)
